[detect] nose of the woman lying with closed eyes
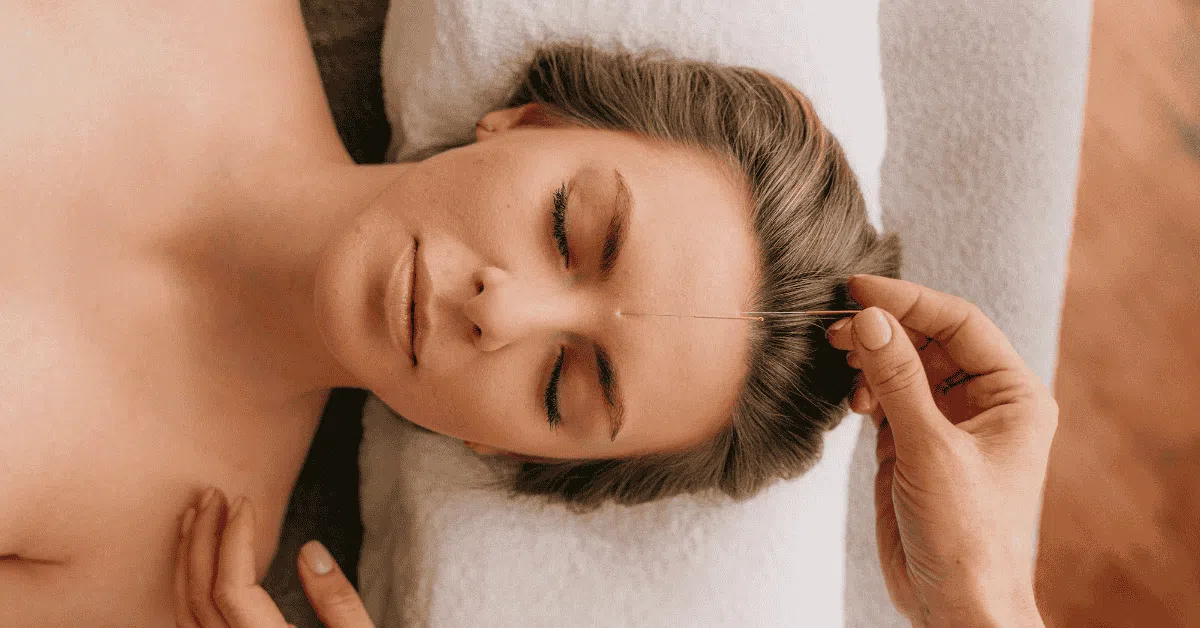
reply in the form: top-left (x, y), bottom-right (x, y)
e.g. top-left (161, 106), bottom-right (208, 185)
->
top-left (463, 267), bottom-right (578, 351)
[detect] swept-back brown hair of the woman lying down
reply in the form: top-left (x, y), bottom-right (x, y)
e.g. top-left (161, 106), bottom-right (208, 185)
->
top-left (496, 44), bottom-right (900, 509)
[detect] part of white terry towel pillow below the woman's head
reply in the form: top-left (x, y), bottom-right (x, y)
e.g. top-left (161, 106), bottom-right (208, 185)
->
top-left (359, 397), bottom-right (859, 628)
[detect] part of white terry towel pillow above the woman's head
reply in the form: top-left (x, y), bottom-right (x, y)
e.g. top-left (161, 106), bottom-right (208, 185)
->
top-left (382, 0), bottom-right (887, 220)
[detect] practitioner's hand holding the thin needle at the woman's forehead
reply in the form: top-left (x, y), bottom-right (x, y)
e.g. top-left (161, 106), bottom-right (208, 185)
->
top-left (829, 276), bottom-right (1058, 627)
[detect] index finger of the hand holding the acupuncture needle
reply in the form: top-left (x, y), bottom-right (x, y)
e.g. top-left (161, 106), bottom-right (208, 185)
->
top-left (850, 275), bottom-right (1025, 375)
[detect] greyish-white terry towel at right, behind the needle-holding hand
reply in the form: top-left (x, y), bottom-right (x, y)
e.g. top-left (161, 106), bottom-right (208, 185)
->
top-left (846, 0), bottom-right (1092, 628)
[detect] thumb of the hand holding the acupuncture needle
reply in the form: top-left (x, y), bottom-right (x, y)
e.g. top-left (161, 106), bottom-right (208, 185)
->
top-left (853, 307), bottom-right (949, 453)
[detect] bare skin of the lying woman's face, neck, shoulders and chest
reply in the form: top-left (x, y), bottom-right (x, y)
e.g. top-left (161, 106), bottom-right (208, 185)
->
top-left (0, 0), bottom-right (756, 627)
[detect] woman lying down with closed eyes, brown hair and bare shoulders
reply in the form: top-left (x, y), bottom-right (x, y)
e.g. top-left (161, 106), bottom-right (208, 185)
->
top-left (0, 0), bottom-right (899, 627)
